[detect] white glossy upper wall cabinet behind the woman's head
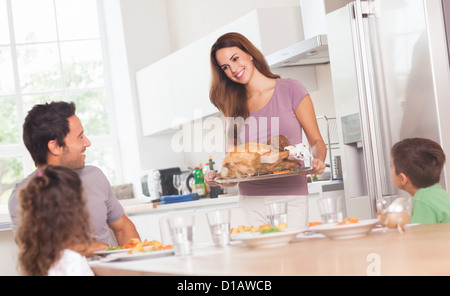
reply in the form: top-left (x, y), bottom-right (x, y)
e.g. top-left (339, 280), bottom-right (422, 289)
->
top-left (136, 6), bottom-right (304, 136)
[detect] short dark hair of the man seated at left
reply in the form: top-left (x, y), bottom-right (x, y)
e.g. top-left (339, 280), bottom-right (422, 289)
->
top-left (23, 102), bottom-right (76, 166)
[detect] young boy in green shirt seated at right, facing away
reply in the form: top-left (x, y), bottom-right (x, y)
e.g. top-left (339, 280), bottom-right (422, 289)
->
top-left (391, 138), bottom-right (450, 224)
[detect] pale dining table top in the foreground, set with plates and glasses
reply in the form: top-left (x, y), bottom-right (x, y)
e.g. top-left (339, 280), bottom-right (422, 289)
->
top-left (91, 224), bottom-right (450, 276)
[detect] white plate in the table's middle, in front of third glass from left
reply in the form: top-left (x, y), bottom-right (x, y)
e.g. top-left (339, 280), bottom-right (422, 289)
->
top-left (231, 228), bottom-right (306, 248)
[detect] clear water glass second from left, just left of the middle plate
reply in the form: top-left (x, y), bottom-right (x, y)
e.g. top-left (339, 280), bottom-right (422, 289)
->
top-left (206, 210), bottom-right (231, 246)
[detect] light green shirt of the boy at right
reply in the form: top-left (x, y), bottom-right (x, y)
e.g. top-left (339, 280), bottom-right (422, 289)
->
top-left (411, 185), bottom-right (450, 224)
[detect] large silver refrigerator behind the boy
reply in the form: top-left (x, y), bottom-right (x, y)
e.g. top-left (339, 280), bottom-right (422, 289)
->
top-left (326, 0), bottom-right (450, 218)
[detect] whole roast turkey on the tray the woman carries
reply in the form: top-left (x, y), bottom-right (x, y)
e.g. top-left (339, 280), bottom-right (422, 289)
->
top-left (220, 136), bottom-right (300, 179)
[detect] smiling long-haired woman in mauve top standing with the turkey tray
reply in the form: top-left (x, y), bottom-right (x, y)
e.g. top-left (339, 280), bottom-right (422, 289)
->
top-left (205, 33), bottom-right (327, 227)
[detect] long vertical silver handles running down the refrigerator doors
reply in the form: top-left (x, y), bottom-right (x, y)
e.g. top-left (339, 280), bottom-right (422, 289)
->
top-left (348, 0), bottom-right (383, 215)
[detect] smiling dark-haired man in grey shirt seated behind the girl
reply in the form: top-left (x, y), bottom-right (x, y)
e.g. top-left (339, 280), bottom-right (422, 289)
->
top-left (8, 102), bottom-right (140, 251)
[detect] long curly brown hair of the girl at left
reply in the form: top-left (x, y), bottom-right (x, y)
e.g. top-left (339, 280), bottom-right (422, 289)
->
top-left (17, 166), bottom-right (92, 276)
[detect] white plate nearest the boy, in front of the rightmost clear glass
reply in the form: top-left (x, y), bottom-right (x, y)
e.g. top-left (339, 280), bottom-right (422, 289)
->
top-left (310, 219), bottom-right (379, 239)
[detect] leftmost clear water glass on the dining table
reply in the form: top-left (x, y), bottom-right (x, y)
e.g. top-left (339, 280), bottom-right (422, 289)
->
top-left (168, 215), bottom-right (194, 256)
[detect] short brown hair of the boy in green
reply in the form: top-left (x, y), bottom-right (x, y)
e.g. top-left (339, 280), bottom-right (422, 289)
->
top-left (391, 138), bottom-right (445, 188)
